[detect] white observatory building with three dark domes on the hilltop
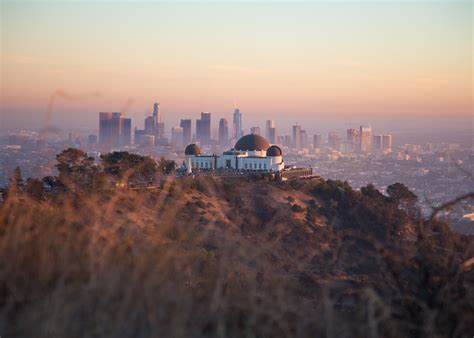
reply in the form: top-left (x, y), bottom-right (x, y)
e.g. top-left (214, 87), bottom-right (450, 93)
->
top-left (184, 134), bottom-right (285, 173)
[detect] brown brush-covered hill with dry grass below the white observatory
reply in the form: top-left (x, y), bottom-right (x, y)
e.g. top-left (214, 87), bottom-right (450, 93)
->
top-left (0, 177), bottom-right (474, 337)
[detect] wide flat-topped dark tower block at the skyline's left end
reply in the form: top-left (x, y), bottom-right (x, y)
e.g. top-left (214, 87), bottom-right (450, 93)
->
top-left (99, 112), bottom-right (127, 147)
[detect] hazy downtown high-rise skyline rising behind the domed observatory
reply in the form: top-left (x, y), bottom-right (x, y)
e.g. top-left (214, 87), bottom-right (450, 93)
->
top-left (93, 103), bottom-right (392, 154)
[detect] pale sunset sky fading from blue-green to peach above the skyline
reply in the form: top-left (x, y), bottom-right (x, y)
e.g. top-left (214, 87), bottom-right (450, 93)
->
top-left (0, 0), bottom-right (473, 135)
